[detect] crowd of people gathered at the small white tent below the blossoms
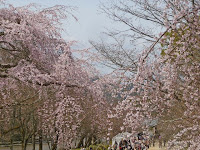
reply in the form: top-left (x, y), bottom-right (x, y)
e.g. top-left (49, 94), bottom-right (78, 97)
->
top-left (112, 135), bottom-right (150, 150)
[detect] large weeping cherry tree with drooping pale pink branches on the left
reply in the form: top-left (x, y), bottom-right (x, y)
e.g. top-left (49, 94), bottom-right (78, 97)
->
top-left (0, 1), bottom-right (106, 150)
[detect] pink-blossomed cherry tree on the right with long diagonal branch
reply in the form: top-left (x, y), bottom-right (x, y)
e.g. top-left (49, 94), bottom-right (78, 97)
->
top-left (93, 0), bottom-right (200, 149)
